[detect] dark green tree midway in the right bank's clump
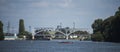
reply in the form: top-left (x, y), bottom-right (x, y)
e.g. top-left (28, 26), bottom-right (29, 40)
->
top-left (102, 16), bottom-right (115, 41)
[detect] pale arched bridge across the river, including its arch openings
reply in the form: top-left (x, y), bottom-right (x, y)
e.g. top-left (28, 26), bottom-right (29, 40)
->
top-left (33, 28), bottom-right (90, 40)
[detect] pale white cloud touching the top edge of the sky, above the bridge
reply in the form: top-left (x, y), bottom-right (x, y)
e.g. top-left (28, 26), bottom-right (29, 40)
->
top-left (32, 0), bottom-right (73, 7)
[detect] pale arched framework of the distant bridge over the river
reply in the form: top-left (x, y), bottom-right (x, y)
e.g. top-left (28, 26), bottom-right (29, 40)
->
top-left (33, 27), bottom-right (88, 40)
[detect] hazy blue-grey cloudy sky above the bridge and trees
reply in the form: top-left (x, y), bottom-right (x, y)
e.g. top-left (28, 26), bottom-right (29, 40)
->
top-left (0, 0), bottom-right (120, 33)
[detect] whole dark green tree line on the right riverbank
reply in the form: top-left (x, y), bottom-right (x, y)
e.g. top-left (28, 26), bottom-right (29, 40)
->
top-left (91, 7), bottom-right (120, 42)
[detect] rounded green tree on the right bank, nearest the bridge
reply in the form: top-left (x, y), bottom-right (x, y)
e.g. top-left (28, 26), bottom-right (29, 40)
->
top-left (91, 19), bottom-right (103, 41)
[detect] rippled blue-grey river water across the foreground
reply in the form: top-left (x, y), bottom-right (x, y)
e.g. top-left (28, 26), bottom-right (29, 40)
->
top-left (0, 40), bottom-right (120, 52)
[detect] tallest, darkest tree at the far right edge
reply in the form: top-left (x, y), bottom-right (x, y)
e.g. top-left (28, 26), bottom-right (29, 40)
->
top-left (111, 7), bottom-right (120, 42)
